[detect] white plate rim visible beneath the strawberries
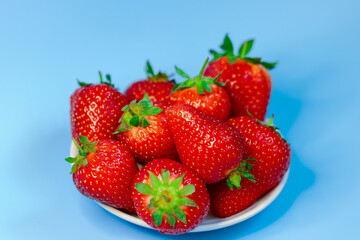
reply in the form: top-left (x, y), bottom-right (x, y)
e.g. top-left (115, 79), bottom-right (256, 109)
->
top-left (70, 143), bottom-right (289, 233)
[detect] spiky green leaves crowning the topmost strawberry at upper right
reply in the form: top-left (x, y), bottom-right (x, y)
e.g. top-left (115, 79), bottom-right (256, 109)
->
top-left (210, 34), bottom-right (277, 69)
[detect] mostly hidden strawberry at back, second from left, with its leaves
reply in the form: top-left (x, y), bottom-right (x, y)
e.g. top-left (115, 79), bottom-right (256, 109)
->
top-left (125, 61), bottom-right (174, 107)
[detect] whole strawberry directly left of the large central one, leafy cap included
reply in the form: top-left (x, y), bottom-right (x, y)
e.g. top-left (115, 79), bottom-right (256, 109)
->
top-left (115, 93), bottom-right (177, 164)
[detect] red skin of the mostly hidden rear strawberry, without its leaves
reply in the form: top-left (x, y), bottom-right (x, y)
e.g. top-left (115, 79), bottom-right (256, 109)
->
top-left (125, 79), bottom-right (174, 107)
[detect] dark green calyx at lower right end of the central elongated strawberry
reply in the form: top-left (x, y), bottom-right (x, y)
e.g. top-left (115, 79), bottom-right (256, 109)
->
top-left (226, 158), bottom-right (257, 190)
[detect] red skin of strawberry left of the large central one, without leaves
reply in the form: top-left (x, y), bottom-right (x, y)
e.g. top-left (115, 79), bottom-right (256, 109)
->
top-left (117, 103), bottom-right (178, 164)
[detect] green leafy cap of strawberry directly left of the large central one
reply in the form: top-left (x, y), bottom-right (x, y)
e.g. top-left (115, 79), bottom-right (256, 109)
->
top-left (113, 93), bottom-right (162, 134)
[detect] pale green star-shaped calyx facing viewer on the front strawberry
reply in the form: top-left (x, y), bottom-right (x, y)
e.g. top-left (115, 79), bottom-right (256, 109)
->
top-left (135, 169), bottom-right (198, 228)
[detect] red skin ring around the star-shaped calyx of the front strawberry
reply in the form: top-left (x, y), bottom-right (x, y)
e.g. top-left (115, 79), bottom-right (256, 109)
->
top-left (132, 159), bottom-right (210, 234)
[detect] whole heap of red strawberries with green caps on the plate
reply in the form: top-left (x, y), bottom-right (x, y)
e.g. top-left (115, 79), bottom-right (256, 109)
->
top-left (66, 36), bottom-right (291, 234)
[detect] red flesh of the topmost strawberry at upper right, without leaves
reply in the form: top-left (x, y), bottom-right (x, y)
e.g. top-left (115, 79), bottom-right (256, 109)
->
top-left (204, 56), bottom-right (271, 121)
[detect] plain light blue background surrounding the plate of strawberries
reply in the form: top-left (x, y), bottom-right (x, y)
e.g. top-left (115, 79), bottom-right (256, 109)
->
top-left (0, 0), bottom-right (360, 240)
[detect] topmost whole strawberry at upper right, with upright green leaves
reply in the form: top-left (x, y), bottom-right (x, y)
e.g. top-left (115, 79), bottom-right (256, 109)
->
top-left (204, 35), bottom-right (276, 120)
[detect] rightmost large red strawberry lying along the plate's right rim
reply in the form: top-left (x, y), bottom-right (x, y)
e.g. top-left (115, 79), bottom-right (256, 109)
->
top-left (209, 116), bottom-right (291, 217)
